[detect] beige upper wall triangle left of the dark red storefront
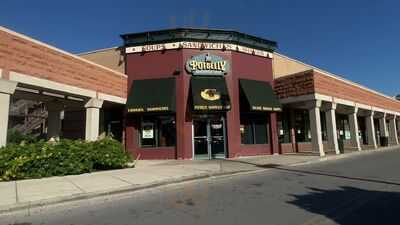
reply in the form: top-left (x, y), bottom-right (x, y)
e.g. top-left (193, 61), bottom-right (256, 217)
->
top-left (78, 47), bottom-right (125, 73)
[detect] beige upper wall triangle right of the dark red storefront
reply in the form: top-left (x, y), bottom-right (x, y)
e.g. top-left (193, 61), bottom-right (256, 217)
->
top-left (272, 53), bottom-right (312, 78)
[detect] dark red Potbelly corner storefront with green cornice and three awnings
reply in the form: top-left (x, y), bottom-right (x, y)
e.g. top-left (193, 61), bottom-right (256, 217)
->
top-left (122, 29), bottom-right (281, 159)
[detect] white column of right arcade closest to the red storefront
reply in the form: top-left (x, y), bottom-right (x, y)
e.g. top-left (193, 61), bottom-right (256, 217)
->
top-left (308, 100), bottom-right (325, 156)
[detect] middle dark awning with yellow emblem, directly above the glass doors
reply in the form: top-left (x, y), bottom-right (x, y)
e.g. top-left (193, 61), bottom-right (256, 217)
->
top-left (190, 77), bottom-right (231, 111)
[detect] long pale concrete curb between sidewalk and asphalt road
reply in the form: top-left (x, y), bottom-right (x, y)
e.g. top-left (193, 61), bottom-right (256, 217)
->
top-left (0, 146), bottom-right (398, 215)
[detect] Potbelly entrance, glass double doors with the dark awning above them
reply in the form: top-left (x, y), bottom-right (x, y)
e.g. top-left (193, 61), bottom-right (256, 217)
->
top-left (190, 75), bottom-right (231, 159)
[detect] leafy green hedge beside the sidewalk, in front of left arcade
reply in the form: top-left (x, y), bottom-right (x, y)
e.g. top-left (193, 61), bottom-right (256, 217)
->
top-left (0, 138), bottom-right (130, 180)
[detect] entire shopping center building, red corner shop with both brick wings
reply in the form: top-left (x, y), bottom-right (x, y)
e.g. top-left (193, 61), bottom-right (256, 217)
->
top-left (0, 28), bottom-right (400, 159)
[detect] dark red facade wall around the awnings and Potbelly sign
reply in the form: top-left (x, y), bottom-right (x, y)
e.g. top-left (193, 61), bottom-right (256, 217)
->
top-left (126, 49), bottom-right (279, 159)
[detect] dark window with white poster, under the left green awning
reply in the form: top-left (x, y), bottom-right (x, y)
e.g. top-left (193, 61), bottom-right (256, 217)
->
top-left (140, 116), bottom-right (176, 148)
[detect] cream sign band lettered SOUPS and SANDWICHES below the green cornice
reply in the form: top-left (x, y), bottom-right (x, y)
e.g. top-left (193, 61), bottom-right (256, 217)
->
top-left (125, 41), bottom-right (273, 59)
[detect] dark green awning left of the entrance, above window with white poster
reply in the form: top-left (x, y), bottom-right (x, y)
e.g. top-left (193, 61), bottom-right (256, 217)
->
top-left (126, 78), bottom-right (176, 113)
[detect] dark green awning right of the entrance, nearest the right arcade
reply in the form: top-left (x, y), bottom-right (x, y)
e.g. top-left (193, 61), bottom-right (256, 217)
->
top-left (239, 79), bottom-right (282, 111)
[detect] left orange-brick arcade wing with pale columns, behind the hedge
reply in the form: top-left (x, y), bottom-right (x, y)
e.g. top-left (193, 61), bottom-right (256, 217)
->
top-left (0, 27), bottom-right (127, 146)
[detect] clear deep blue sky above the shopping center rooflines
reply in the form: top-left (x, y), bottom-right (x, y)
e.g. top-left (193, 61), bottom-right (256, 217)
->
top-left (0, 0), bottom-right (400, 95)
